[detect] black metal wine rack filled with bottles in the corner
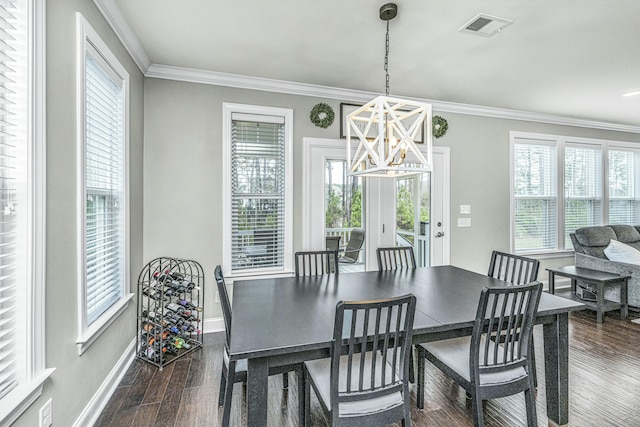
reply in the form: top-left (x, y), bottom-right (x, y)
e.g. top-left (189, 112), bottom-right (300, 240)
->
top-left (136, 257), bottom-right (204, 370)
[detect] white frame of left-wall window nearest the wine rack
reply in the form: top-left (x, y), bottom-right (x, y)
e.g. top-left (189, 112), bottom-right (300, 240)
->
top-left (76, 12), bottom-right (134, 355)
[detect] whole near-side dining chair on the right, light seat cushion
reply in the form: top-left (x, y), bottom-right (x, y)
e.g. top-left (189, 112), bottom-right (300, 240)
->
top-left (418, 282), bottom-right (542, 427)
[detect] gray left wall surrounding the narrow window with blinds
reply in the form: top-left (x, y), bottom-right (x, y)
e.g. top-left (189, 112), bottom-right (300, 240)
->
top-left (14, 0), bottom-right (144, 427)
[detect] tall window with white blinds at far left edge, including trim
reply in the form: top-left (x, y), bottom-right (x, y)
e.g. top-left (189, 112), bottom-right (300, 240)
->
top-left (0, 0), bottom-right (54, 425)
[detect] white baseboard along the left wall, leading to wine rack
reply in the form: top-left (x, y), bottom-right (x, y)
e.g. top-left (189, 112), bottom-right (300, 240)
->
top-left (73, 338), bottom-right (136, 427)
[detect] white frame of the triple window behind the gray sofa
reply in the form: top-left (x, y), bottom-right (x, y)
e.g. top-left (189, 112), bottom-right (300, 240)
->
top-left (509, 131), bottom-right (640, 256)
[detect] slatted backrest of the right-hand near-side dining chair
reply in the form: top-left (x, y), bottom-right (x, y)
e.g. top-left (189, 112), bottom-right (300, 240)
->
top-left (470, 282), bottom-right (542, 384)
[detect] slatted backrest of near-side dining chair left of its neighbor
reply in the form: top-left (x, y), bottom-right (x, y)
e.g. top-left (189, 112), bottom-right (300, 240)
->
top-left (331, 294), bottom-right (416, 413)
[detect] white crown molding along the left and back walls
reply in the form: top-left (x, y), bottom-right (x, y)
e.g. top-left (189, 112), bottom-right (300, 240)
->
top-left (94, 0), bottom-right (640, 133)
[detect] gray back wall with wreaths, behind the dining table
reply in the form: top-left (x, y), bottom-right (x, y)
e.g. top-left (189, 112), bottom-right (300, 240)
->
top-left (143, 78), bottom-right (640, 319)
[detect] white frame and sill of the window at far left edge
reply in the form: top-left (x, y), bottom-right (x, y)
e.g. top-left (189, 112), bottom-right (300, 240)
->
top-left (0, 0), bottom-right (55, 425)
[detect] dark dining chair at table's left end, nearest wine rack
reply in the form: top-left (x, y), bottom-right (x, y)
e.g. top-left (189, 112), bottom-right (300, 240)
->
top-left (214, 265), bottom-right (304, 427)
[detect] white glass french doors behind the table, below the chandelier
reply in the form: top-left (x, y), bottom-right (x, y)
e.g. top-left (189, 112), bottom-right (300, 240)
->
top-left (302, 138), bottom-right (449, 271)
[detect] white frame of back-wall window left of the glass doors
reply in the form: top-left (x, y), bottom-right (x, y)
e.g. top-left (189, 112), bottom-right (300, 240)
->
top-left (222, 102), bottom-right (293, 279)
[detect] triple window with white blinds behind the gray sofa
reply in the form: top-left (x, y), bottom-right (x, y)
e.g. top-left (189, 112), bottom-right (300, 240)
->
top-left (511, 132), bottom-right (640, 253)
